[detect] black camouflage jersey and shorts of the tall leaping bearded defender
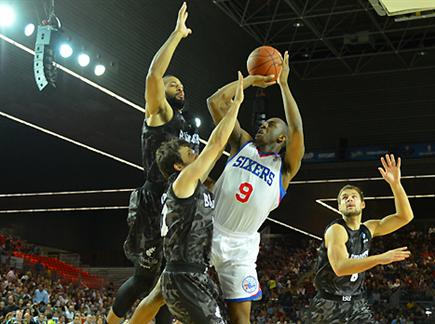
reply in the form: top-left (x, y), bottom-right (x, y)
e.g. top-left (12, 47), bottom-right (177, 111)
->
top-left (124, 109), bottom-right (199, 268)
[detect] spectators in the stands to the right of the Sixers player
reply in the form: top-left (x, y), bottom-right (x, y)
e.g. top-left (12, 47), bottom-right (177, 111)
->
top-left (251, 227), bottom-right (435, 324)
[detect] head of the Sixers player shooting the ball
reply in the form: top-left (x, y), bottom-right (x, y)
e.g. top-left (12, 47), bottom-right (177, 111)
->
top-left (255, 118), bottom-right (288, 152)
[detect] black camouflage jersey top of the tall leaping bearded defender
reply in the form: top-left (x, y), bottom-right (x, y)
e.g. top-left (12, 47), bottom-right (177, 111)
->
top-left (142, 109), bottom-right (199, 185)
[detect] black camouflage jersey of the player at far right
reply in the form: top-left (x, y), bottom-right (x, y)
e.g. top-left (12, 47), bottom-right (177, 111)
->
top-left (314, 219), bottom-right (372, 296)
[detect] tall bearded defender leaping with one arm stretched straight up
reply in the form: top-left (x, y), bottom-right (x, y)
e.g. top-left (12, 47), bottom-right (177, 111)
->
top-left (107, 4), bottom-right (199, 324)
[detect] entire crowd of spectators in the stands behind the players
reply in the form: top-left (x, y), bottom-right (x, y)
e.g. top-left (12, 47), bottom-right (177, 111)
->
top-left (0, 224), bottom-right (435, 324)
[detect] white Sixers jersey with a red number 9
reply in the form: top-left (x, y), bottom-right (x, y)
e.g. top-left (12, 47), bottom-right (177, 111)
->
top-left (214, 142), bottom-right (286, 234)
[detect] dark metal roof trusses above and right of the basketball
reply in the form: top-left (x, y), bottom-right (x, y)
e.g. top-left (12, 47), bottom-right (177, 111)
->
top-left (213, 0), bottom-right (435, 79)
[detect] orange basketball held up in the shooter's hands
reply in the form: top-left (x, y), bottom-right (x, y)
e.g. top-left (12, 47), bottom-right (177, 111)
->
top-left (246, 46), bottom-right (282, 80)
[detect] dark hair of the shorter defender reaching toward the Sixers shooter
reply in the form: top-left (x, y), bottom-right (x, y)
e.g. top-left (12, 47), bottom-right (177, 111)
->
top-left (156, 138), bottom-right (190, 179)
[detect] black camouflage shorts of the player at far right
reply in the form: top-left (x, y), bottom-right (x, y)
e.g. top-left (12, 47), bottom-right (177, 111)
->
top-left (304, 296), bottom-right (373, 324)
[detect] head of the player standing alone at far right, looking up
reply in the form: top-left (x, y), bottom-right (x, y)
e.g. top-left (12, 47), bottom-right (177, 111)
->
top-left (337, 185), bottom-right (366, 217)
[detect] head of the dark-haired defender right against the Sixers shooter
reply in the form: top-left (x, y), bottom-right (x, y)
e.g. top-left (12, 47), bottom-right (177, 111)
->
top-left (156, 138), bottom-right (198, 179)
